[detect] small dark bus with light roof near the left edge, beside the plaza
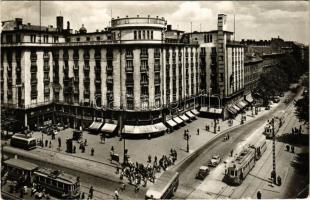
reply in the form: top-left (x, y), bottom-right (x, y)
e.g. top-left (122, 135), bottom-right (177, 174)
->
top-left (11, 134), bottom-right (37, 150)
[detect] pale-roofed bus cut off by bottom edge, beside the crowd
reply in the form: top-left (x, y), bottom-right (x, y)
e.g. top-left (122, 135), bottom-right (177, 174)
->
top-left (145, 170), bottom-right (179, 199)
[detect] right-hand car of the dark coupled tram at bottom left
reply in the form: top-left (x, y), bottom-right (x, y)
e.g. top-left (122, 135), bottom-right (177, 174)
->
top-left (34, 168), bottom-right (80, 199)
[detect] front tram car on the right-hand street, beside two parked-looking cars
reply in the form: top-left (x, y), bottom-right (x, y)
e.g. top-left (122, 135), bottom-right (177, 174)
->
top-left (224, 148), bottom-right (255, 185)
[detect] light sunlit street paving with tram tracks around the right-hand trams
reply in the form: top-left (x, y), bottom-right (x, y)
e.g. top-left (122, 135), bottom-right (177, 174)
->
top-left (176, 86), bottom-right (308, 199)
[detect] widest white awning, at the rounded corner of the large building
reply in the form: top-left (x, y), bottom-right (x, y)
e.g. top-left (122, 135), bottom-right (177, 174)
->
top-left (123, 122), bottom-right (167, 135)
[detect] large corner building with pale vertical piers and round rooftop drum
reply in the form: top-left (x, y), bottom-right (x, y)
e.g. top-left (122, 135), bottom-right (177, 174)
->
top-left (1, 16), bottom-right (200, 131)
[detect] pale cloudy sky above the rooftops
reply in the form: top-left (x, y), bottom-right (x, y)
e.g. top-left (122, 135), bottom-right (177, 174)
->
top-left (1, 1), bottom-right (310, 44)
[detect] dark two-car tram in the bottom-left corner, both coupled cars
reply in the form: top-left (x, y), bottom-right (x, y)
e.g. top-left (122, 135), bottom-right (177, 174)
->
top-left (1, 158), bottom-right (80, 199)
